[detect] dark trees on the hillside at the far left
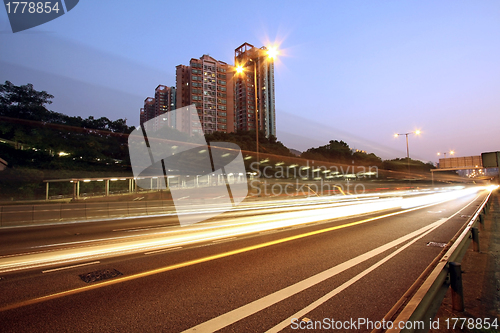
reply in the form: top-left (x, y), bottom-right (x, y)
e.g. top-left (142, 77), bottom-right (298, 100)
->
top-left (0, 81), bottom-right (134, 170)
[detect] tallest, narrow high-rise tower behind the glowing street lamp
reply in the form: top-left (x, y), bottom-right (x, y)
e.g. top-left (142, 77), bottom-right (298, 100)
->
top-left (234, 43), bottom-right (276, 137)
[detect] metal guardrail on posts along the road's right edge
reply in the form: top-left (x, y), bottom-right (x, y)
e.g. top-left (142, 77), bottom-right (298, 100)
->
top-left (371, 188), bottom-right (492, 333)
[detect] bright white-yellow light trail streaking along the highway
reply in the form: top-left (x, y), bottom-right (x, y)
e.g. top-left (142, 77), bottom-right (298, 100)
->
top-left (0, 187), bottom-right (484, 273)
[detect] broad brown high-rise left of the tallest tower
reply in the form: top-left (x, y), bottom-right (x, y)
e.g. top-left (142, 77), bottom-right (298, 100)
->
top-left (176, 54), bottom-right (235, 134)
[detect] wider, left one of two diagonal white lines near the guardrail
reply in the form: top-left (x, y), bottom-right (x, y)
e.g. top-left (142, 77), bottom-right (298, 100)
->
top-left (180, 218), bottom-right (448, 332)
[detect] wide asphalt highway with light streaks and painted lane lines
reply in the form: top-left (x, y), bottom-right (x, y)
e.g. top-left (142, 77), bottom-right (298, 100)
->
top-left (0, 188), bottom-right (487, 332)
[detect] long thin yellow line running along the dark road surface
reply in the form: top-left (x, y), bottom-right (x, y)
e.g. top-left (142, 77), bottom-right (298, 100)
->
top-left (0, 196), bottom-right (477, 312)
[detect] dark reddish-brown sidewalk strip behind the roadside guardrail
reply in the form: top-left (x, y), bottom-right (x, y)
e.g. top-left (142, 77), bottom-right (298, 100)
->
top-left (430, 190), bottom-right (500, 333)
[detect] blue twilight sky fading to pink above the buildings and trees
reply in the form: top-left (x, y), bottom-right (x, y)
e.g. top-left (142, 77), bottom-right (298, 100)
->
top-left (0, 0), bottom-right (500, 162)
